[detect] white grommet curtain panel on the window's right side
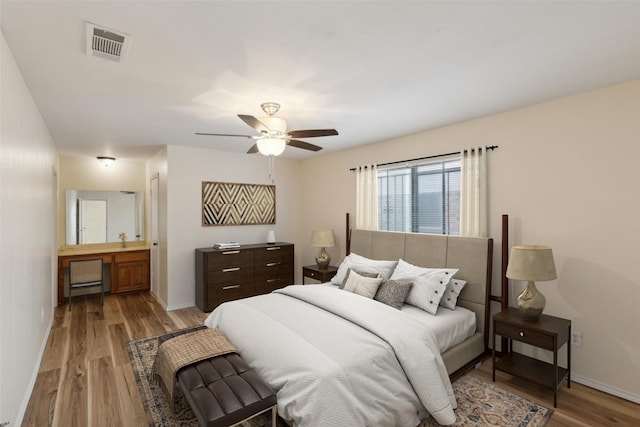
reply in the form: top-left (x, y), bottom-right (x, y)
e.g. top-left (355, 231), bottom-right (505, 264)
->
top-left (460, 146), bottom-right (487, 237)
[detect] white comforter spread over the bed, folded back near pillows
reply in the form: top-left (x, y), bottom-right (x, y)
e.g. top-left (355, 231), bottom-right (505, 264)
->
top-left (205, 285), bottom-right (456, 427)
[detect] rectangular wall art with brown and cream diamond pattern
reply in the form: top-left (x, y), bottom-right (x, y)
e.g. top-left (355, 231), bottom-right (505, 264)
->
top-left (202, 181), bottom-right (276, 226)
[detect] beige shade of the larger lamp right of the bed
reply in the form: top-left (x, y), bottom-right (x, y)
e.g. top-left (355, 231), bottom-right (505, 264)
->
top-left (507, 246), bottom-right (558, 282)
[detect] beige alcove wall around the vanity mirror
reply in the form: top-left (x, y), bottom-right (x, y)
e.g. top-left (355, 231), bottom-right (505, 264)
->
top-left (58, 156), bottom-right (147, 246)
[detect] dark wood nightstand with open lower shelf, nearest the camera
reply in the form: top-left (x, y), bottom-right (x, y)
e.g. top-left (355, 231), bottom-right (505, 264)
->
top-left (492, 307), bottom-right (571, 408)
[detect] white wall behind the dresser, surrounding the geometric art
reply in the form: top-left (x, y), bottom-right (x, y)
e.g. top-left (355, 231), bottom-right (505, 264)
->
top-left (160, 146), bottom-right (302, 310)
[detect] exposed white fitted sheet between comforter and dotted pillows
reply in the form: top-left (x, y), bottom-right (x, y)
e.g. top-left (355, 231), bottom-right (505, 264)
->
top-left (400, 304), bottom-right (476, 353)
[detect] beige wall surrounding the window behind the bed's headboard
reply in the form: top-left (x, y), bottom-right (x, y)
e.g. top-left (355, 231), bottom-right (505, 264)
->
top-left (299, 81), bottom-right (640, 402)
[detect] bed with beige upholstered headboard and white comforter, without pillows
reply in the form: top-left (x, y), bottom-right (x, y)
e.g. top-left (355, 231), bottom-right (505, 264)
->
top-left (205, 229), bottom-right (493, 426)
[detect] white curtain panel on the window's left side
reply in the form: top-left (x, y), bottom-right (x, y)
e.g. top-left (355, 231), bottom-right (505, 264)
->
top-left (356, 165), bottom-right (378, 230)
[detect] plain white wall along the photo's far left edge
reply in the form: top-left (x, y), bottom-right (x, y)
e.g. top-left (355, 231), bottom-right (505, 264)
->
top-left (0, 35), bottom-right (57, 426)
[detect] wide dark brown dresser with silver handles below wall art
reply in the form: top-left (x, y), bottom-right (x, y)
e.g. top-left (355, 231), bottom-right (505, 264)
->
top-left (196, 242), bottom-right (294, 312)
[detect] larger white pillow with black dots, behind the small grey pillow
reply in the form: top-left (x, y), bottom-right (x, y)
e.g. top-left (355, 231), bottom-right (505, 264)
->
top-left (391, 259), bottom-right (458, 314)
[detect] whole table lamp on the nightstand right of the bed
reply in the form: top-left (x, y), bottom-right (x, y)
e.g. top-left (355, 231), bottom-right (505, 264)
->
top-left (507, 246), bottom-right (558, 321)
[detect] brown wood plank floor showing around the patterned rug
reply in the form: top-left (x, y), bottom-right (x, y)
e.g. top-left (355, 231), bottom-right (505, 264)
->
top-left (22, 293), bottom-right (640, 427)
